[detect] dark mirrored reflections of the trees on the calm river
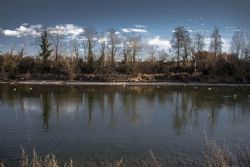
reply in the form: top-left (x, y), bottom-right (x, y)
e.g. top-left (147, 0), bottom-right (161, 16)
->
top-left (0, 85), bottom-right (249, 134)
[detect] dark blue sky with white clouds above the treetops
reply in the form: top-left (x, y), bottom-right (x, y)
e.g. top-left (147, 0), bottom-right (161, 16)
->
top-left (0, 0), bottom-right (250, 54)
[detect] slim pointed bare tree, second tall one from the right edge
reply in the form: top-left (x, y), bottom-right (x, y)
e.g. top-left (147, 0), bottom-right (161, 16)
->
top-left (209, 27), bottom-right (223, 59)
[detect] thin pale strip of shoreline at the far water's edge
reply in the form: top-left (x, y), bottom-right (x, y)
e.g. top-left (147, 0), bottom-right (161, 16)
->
top-left (0, 80), bottom-right (250, 87)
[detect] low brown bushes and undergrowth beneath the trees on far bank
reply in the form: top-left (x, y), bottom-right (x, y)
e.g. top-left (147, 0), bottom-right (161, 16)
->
top-left (0, 51), bottom-right (250, 83)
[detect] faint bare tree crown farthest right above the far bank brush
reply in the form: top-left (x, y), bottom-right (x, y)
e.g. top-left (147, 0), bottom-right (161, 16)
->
top-left (230, 30), bottom-right (246, 58)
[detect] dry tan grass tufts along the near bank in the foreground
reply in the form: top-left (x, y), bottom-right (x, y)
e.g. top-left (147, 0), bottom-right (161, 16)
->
top-left (0, 139), bottom-right (250, 167)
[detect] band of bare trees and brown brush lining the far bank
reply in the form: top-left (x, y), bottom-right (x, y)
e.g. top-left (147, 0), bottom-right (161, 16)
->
top-left (0, 26), bottom-right (250, 83)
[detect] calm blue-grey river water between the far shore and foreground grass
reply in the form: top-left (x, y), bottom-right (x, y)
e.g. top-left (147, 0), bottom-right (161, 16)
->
top-left (0, 85), bottom-right (250, 166)
